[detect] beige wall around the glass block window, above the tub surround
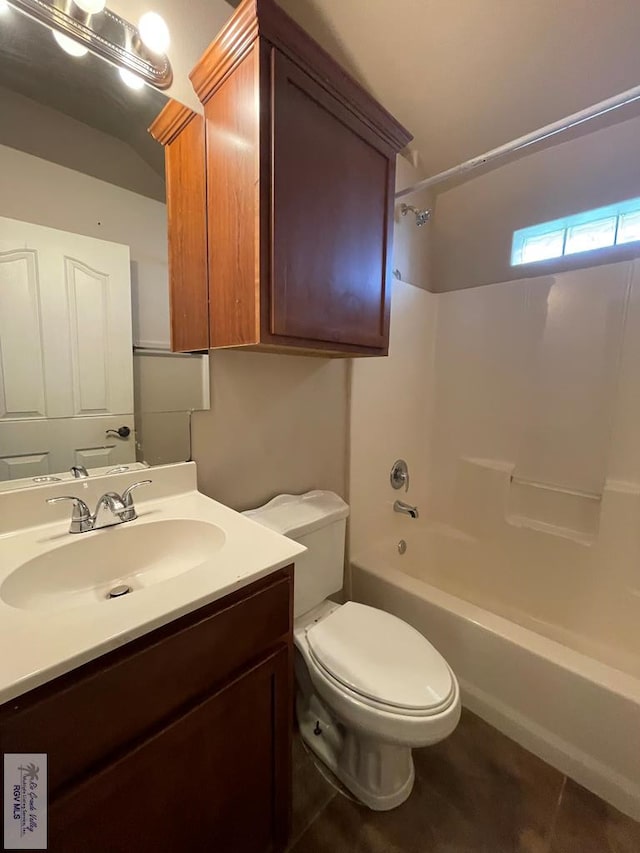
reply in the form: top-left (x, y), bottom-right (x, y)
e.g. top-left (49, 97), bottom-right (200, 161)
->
top-left (427, 111), bottom-right (640, 292)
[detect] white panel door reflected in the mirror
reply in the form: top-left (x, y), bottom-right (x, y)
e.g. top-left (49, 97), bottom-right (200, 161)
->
top-left (0, 217), bottom-right (135, 479)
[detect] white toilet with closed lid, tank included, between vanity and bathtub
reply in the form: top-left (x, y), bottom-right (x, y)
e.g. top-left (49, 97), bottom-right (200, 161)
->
top-left (245, 491), bottom-right (460, 811)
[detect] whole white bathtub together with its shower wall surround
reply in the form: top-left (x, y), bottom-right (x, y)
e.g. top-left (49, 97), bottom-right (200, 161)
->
top-left (350, 261), bottom-right (640, 817)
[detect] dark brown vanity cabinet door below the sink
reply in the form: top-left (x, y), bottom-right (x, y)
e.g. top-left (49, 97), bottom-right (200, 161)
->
top-left (49, 649), bottom-right (291, 853)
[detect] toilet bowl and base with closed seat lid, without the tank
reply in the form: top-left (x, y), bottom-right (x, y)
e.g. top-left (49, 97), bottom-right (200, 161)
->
top-left (294, 602), bottom-right (460, 811)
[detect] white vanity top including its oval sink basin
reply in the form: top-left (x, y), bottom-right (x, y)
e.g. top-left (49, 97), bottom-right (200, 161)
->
top-left (0, 463), bottom-right (305, 703)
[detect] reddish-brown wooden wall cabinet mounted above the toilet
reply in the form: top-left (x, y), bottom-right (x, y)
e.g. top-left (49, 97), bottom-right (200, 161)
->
top-left (155, 0), bottom-right (411, 356)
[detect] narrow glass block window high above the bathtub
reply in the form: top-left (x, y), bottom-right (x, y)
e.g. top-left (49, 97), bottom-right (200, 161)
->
top-left (511, 198), bottom-right (640, 266)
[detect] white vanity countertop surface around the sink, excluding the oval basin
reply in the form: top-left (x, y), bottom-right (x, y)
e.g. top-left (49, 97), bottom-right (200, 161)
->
top-left (0, 463), bottom-right (306, 703)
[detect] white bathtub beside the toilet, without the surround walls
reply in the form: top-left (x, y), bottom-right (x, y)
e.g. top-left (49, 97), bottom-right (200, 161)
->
top-left (351, 540), bottom-right (640, 820)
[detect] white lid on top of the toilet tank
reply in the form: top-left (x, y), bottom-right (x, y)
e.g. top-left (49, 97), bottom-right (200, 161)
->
top-left (243, 489), bottom-right (349, 538)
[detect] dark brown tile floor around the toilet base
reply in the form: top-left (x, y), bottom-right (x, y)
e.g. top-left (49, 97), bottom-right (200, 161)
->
top-left (289, 711), bottom-right (640, 853)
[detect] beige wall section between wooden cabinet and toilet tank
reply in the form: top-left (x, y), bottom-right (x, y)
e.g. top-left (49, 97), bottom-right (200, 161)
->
top-left (192, 350), bottom-right (348, 509)
